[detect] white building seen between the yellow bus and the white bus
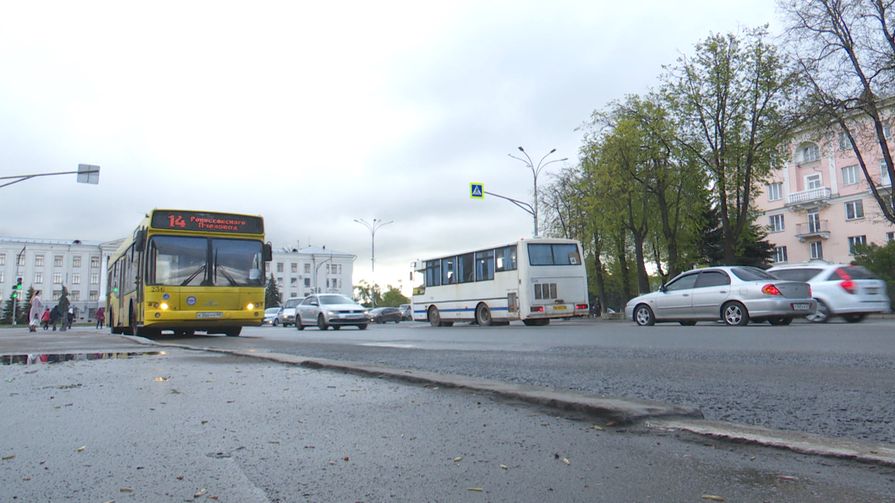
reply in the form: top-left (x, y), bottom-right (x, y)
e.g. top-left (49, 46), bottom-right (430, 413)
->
top-left (267, 246), bottom-right (357, 300)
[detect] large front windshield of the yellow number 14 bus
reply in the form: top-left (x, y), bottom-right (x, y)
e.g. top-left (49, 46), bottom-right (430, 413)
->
top-left (146, 236), bottom-right (263, 286)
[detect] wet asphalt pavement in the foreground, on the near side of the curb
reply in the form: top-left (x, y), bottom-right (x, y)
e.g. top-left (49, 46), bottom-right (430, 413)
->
top-left (0, 329), bottom-right (895, 503)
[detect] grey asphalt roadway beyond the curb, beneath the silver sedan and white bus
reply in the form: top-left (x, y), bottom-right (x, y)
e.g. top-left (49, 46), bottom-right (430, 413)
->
top-left (178, 318), bottom-right (895, 443)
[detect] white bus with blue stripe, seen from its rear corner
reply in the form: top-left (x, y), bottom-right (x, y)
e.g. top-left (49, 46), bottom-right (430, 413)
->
top-left (413, 238), bottom-right (588, 327)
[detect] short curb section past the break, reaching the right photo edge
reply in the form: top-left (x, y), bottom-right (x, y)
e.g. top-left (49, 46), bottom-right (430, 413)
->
top-left (644, 418), bottom-right (895, 466)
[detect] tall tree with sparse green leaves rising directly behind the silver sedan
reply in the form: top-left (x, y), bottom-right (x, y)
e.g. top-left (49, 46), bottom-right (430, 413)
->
top-left (663, 28), bottom-right (797, 263)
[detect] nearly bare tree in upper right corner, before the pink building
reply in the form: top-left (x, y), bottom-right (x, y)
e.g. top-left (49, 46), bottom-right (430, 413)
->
top-left (781, 0), bottom-right (895, 223)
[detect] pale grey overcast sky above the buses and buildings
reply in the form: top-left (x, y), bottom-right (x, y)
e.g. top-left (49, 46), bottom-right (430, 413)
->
top-left (0, 0), bottom-right (779, 288)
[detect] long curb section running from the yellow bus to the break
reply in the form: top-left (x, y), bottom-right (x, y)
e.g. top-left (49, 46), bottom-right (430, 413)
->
top-left (132, 338), bottom-right (703, 425)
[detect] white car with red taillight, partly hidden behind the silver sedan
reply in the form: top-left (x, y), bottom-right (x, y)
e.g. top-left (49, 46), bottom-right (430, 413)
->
top-left (768, 262), bottom-right (891, 323)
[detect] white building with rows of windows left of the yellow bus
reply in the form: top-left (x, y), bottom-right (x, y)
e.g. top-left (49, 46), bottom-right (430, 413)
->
top-left (0, 237), bottom-right (121, 321)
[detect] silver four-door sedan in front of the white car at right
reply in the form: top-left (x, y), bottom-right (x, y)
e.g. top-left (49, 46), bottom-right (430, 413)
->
top-left (625, 266), bottom-right (817, 326)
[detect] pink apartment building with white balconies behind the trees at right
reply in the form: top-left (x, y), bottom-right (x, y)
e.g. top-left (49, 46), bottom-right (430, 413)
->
top-left (755, 124), bottom-right (895, 263)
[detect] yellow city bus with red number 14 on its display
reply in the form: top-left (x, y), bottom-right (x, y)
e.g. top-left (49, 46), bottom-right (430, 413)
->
top-left (106, 209), bottom-right (272, 337)
